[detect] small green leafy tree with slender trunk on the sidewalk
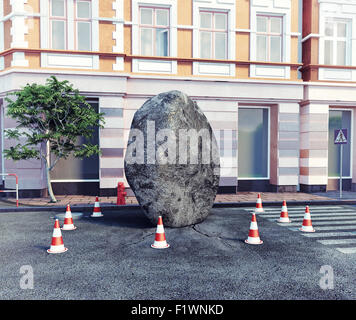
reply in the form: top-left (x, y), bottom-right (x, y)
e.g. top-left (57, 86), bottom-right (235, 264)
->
top-left (4, 76), bottom-right (104, 202)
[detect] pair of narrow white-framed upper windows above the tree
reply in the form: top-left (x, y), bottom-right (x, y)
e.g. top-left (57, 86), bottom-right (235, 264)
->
top-left (49, 0), bottom-right (92, 51)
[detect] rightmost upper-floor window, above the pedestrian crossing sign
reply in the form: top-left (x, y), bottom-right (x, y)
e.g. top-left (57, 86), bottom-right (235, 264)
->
top-left (324, 19), bottom-right (351, 66)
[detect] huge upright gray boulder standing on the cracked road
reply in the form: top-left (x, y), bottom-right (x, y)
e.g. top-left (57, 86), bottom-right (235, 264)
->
top-left (125, 91), bottom-right (220, 227)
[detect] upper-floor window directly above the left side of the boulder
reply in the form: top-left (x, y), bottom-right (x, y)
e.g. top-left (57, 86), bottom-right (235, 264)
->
top-left (139, 7), bottom-right (169, 57)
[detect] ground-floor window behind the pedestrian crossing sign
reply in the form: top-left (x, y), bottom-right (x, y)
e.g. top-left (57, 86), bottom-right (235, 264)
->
top-left (328, 110), bottom-right (352, 178)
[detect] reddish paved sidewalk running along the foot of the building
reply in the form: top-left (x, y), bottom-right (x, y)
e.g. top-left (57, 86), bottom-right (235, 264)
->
top-left (0, 191), bottom-right (356, 212)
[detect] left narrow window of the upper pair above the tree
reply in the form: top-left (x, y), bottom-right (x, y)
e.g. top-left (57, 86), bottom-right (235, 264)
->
top-left (50, 0), bottom-right (67, 50)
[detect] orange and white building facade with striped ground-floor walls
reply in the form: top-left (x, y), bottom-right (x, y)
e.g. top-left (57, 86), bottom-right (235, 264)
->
top-left (0, 0), bottom-right (356, 196)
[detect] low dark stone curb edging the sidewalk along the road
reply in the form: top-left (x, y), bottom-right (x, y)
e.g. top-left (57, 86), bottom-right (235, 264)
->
top-left (0, 199), bottom-right (356, 213)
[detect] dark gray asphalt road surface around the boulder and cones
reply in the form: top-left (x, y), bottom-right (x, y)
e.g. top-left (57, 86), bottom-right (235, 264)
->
top-left (0, 206), bottom-right (356, 300)
